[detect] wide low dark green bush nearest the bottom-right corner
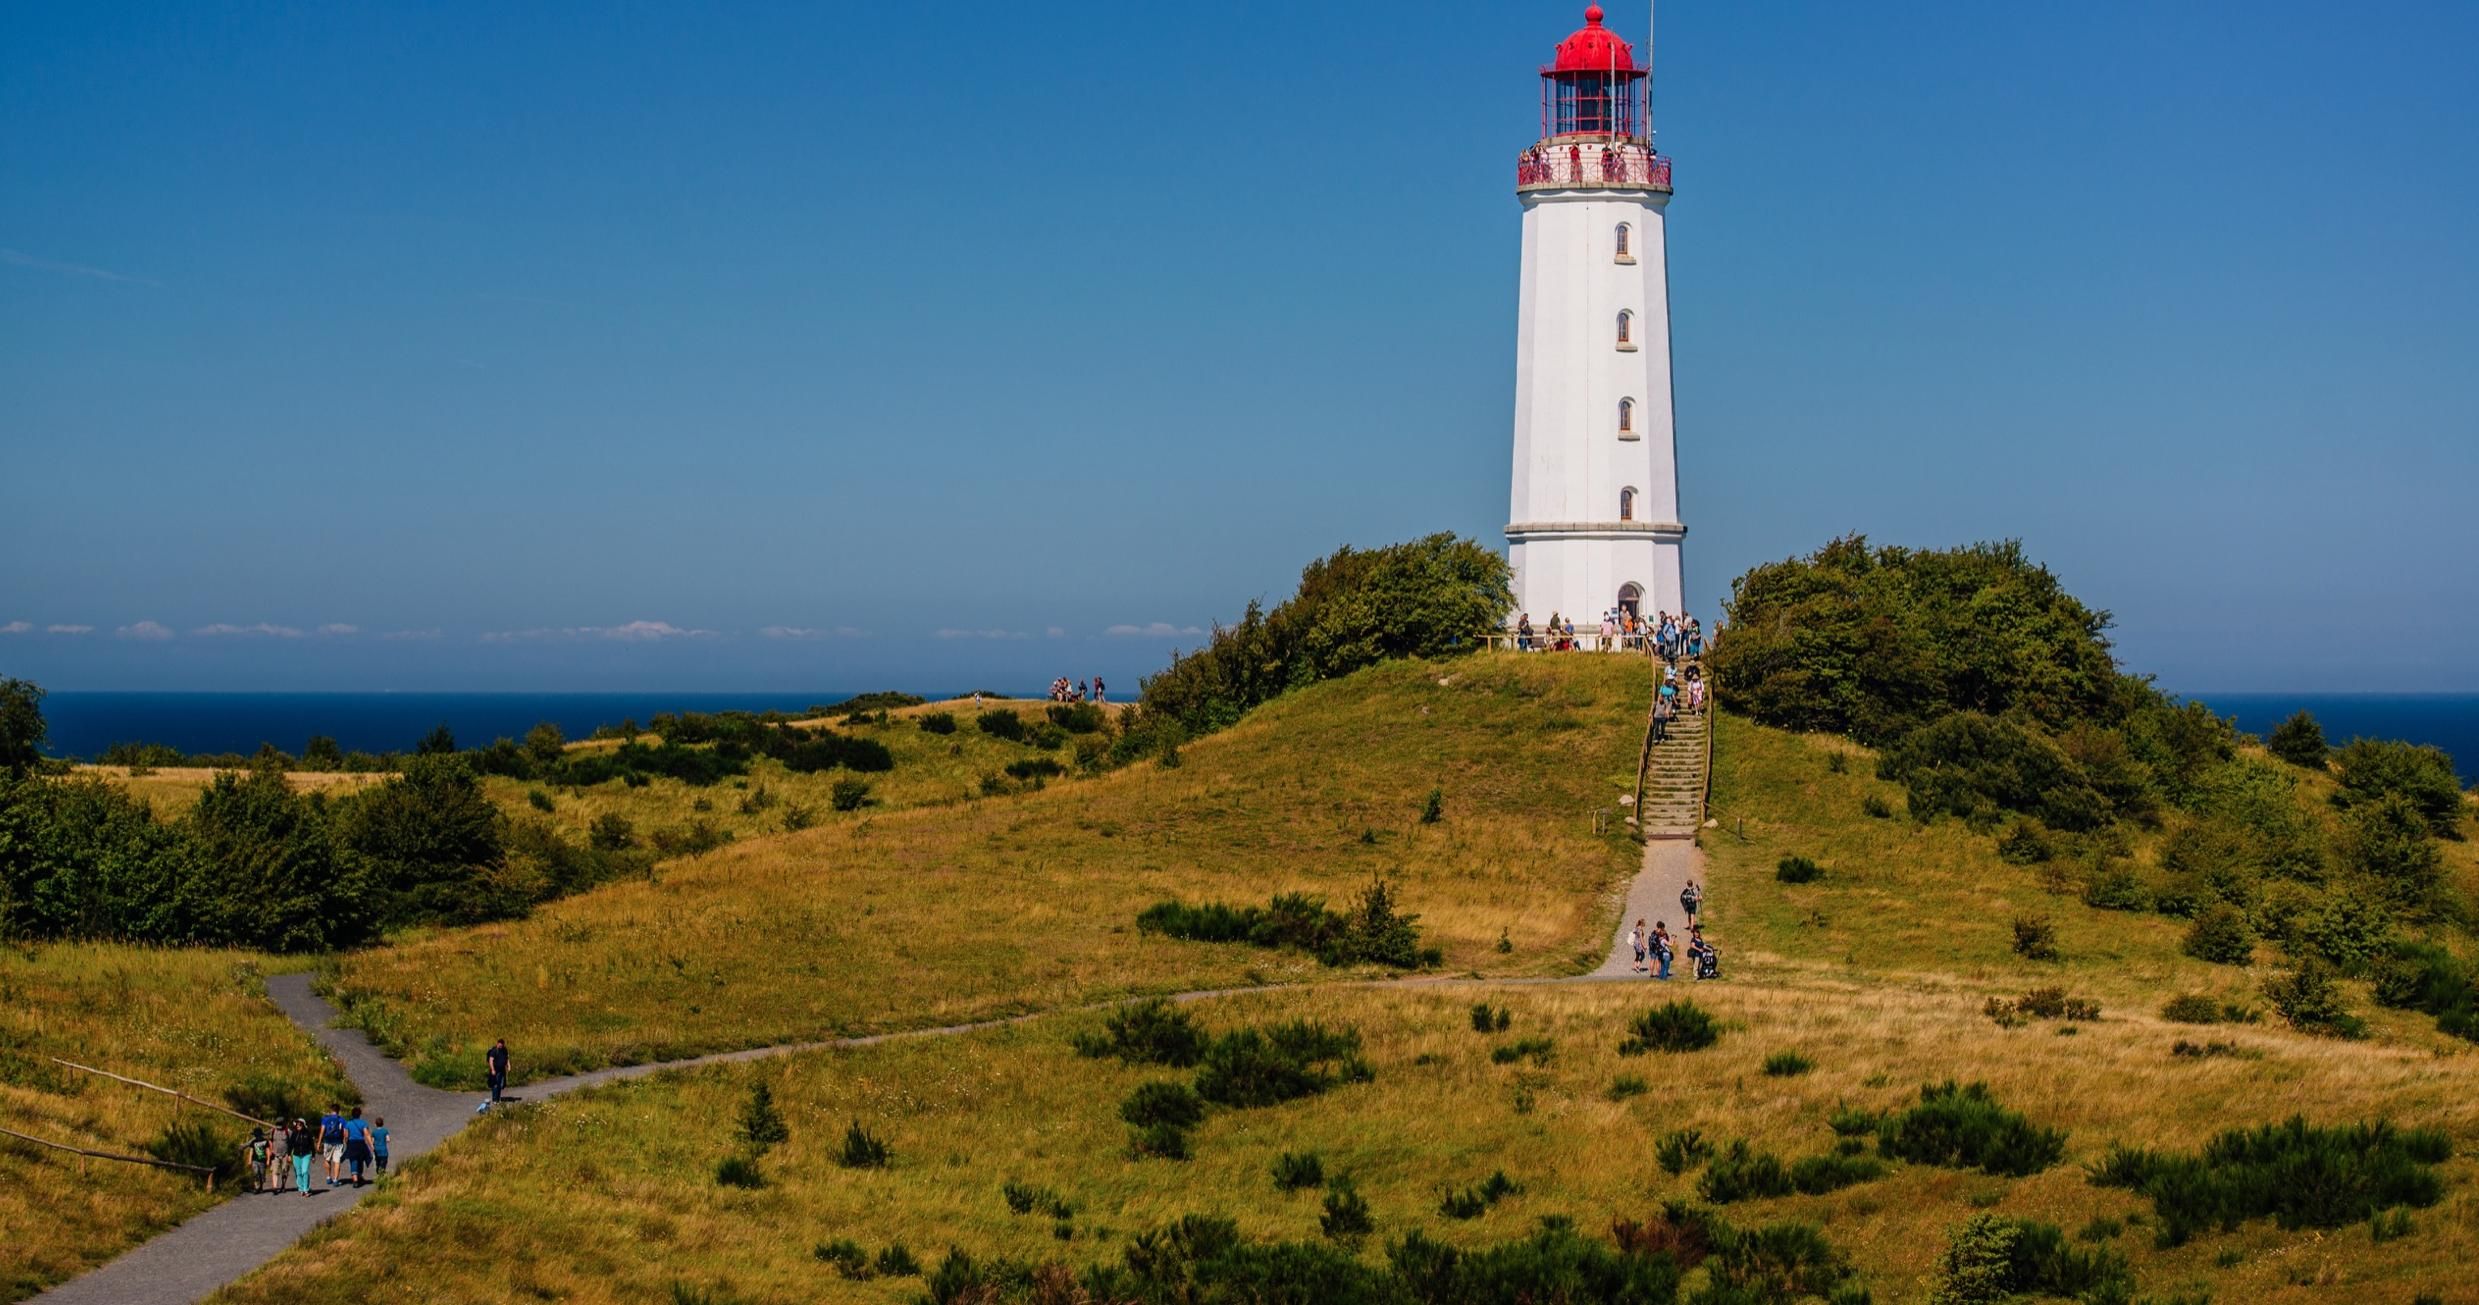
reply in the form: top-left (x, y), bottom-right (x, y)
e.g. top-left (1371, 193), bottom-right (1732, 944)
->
top-left (2090, 1116), bottom-right (2452, 1245)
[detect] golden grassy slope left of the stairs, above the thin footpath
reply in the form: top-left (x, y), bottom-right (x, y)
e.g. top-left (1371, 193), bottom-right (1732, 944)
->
top-left (319, 657), bottom-right (1649, 1082)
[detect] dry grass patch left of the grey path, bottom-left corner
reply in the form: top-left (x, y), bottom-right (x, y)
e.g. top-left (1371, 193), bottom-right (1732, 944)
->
top-left (0, 943), bottom-right (347, 1300)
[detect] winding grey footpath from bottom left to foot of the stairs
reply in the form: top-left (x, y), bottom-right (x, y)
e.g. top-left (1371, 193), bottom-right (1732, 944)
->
top-left (35, 764), bottom-right (1703, 1305)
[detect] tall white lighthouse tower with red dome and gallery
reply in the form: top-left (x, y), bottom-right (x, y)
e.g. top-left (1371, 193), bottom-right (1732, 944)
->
top-left (1507, 5), bottom-right (1688, 630)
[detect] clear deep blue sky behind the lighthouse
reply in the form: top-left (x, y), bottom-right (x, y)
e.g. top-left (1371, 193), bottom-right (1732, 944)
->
top-left (0, 0), bottom-right (2479, 690)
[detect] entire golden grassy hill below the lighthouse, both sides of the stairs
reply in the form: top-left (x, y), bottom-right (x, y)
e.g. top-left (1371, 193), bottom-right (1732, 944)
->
top-left (221, 679), bottom-right (2479, 1303)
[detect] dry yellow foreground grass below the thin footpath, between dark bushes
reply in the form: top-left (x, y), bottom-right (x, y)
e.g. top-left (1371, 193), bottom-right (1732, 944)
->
top-left (203, 978), bottom-right (2479, 1305)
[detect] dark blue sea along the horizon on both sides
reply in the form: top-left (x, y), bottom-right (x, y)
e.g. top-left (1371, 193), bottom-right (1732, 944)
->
top-left (42, 692), bottom-right (2479, 784)
